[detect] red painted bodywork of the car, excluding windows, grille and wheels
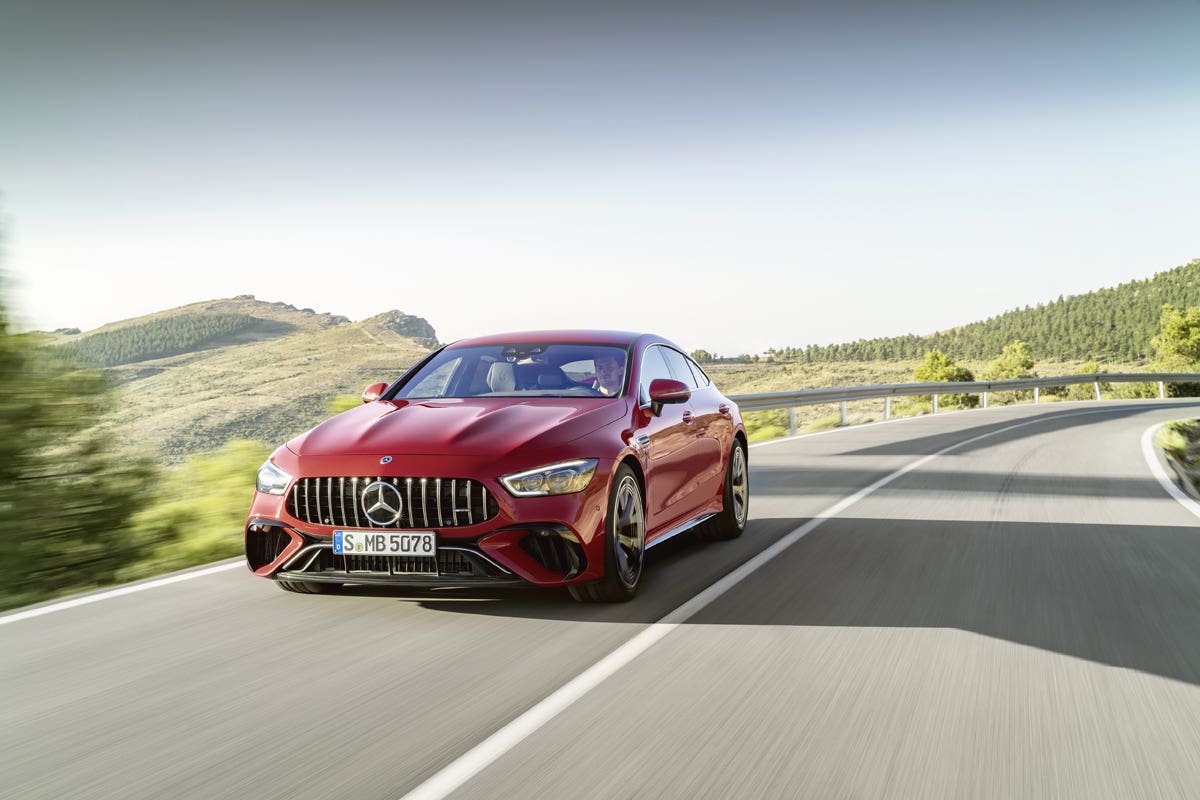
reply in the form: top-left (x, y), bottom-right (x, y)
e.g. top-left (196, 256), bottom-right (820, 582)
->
top-left (246, 331), bottom-right (745, 585)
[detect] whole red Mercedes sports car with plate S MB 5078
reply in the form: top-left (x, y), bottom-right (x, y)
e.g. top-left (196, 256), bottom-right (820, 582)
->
top-left (246, 331), bottom-right (750, 601)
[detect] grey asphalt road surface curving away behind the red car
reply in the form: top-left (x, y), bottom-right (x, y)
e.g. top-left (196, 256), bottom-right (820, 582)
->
top-left (0, 402), bottom-right (1200, 800)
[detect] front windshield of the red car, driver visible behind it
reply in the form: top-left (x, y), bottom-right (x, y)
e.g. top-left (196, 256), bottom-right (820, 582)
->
top-left (394, 342), bottom-right (629, 399)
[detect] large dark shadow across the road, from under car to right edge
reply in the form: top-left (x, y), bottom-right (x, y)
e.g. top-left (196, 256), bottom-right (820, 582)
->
top-left (398, 517), bottom-right (1200, 685)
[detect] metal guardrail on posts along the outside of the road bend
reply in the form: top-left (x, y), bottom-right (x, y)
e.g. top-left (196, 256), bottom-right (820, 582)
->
top-left (730, 372), bottom-right (1200, 434)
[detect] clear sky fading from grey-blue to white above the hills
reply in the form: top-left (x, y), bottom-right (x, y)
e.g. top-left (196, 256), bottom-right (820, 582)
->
top-left (0, 0), bottom-right (1200, 355)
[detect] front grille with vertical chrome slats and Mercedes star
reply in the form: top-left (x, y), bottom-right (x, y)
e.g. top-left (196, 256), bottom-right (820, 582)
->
top-left (288, 477), bottom-right (500, 529)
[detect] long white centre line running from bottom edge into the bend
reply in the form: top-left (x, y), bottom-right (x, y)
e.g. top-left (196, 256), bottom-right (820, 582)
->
top-left (401, 407), bottom-right (1127, 800)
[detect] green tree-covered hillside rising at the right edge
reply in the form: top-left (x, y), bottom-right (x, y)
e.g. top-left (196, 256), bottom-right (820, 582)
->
top-left (774, 260), bottom-right (1200, 363)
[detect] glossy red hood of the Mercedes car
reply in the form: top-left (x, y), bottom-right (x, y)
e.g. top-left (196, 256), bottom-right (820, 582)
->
top-left (288, 398), bottom-right (626, 456)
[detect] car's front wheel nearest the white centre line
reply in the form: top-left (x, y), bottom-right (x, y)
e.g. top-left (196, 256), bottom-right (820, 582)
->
top-left (568, 464), bottom-right (646, 603)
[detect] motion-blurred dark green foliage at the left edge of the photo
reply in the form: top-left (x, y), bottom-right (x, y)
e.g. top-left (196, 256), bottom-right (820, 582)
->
top-left (0, 276), bottom-right (154, 608)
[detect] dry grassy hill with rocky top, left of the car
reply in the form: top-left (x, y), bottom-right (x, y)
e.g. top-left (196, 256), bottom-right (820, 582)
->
top-left (56, 296), bottom-right (436, 461)
